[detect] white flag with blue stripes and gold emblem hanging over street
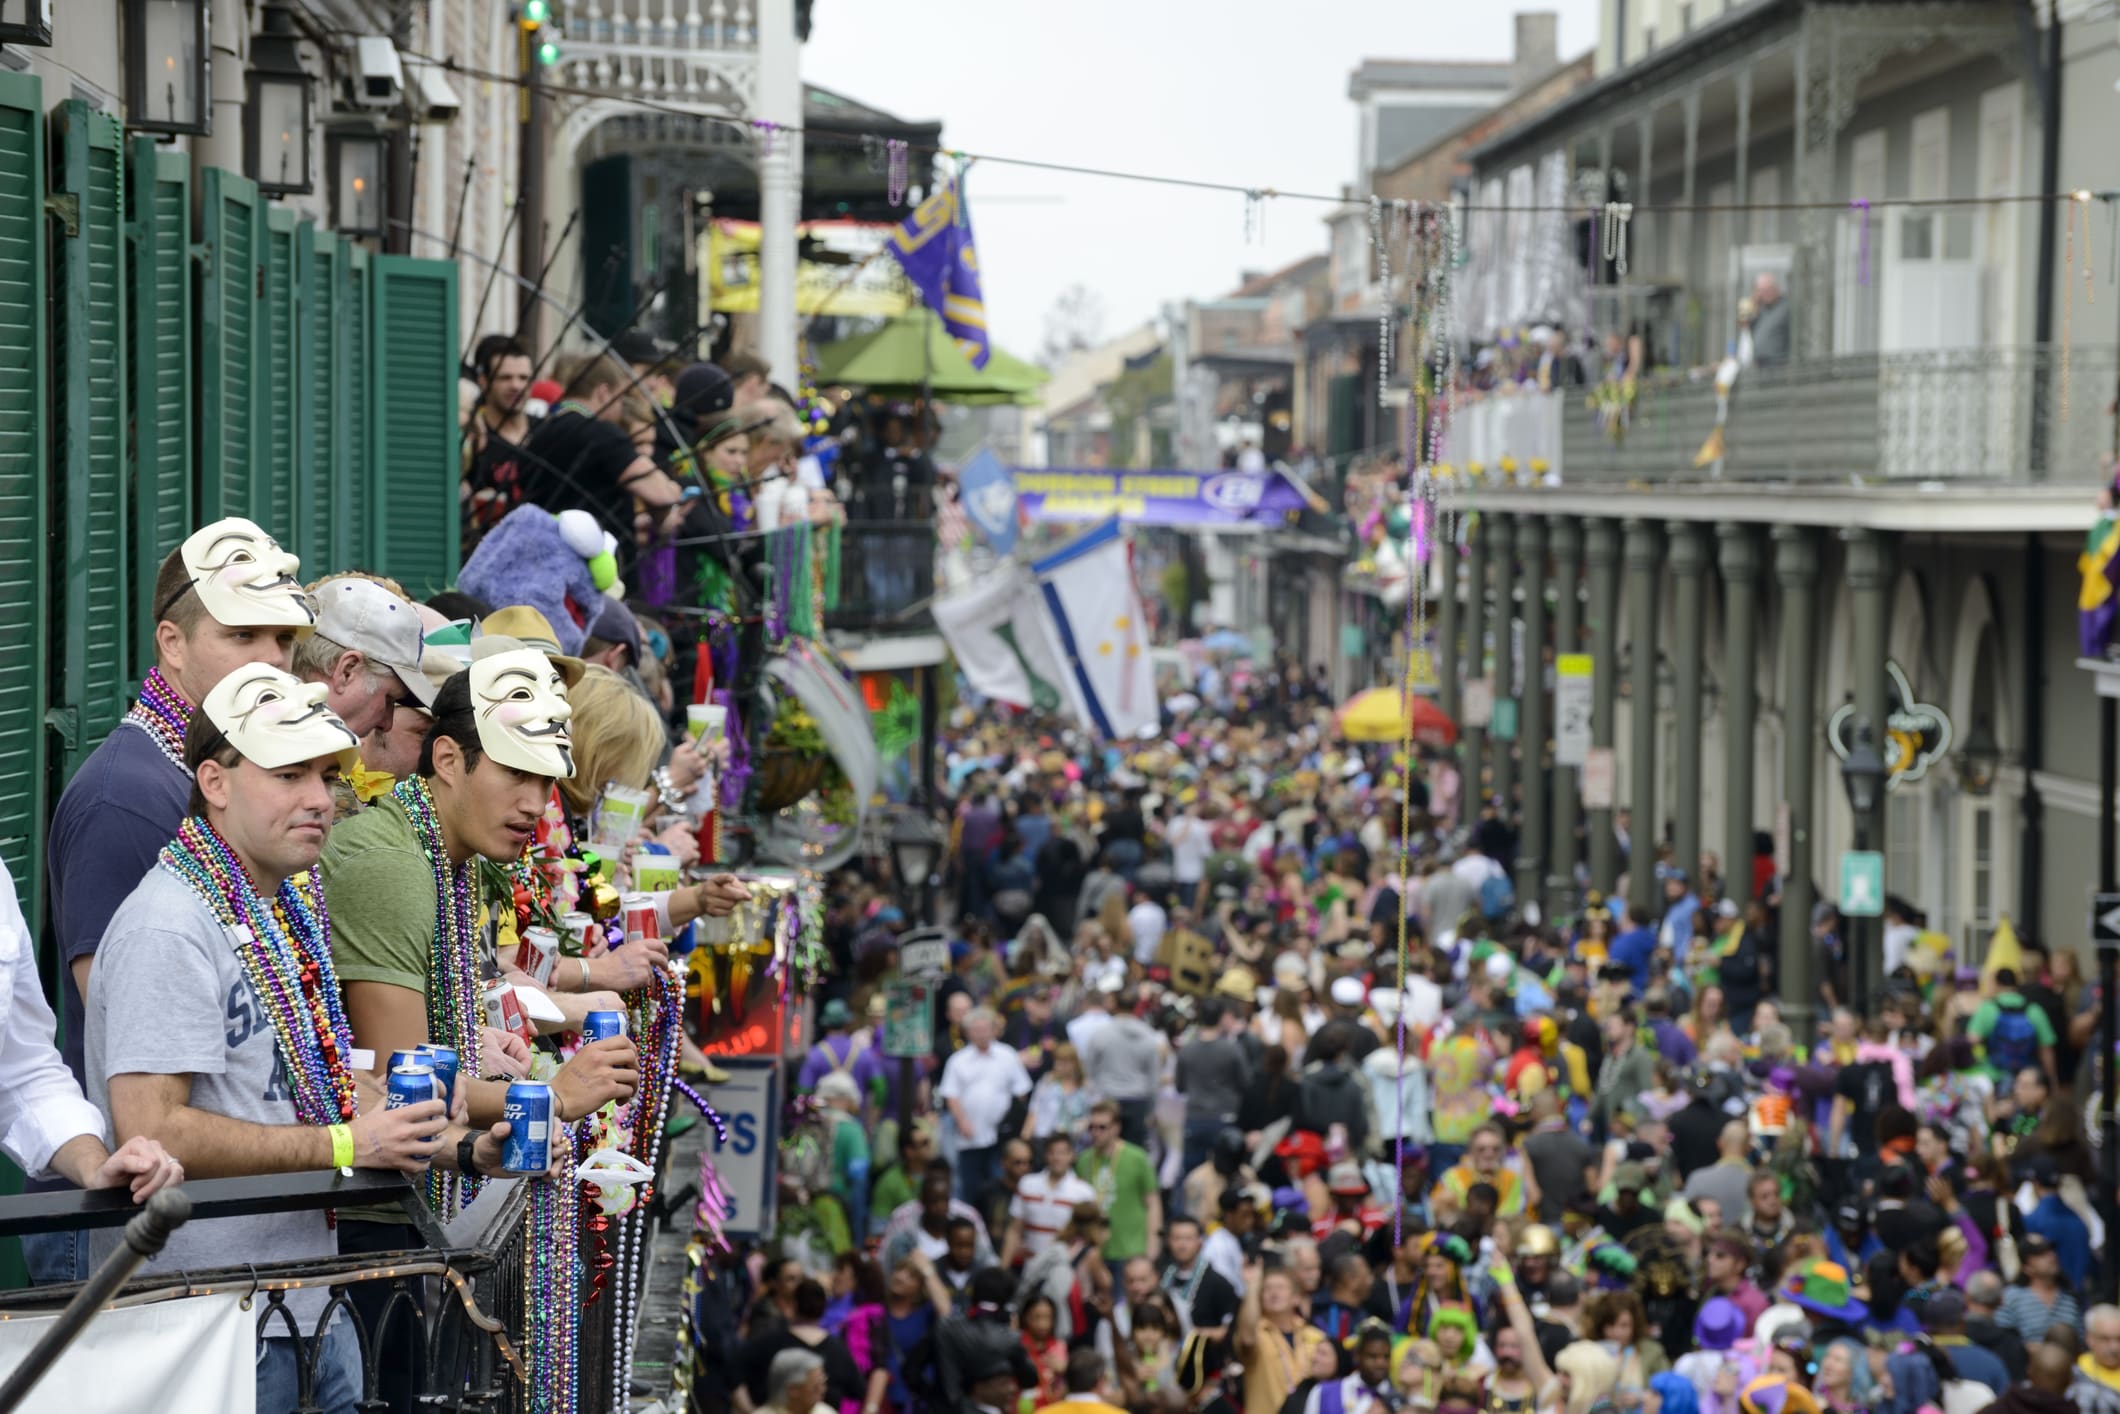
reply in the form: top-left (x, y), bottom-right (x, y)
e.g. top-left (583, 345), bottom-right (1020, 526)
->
top-left (1032, 519), bottom-right (1158, 738)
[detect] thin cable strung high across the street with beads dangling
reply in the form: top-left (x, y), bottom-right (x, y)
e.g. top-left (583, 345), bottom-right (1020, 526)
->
top-left (401, 51), bottom-right (2120, 216)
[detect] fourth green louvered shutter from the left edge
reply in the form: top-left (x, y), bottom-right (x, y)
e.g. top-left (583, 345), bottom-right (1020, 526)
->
top-left (199, 167), bottom-right (259, 522)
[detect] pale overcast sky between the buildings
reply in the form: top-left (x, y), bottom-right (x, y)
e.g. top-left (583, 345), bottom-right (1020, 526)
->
top-left (803, 0), bottom-right (1596, 358)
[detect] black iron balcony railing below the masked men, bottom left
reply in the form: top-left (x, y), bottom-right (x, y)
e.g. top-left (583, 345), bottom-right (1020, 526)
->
top-left (0, 1170), bottom-right (526, 1414)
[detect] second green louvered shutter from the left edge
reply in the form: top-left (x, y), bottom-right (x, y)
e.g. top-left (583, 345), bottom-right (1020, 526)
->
top-left (51, 98), bottom-right (131, 774)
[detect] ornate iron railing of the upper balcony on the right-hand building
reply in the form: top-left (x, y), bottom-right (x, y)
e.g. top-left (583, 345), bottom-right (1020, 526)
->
top-left (1551, 348), bottom-right (2120, 485)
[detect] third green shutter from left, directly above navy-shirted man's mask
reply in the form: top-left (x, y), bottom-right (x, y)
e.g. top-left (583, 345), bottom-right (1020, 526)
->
top-left (125, 138), bottom-right (193, 676)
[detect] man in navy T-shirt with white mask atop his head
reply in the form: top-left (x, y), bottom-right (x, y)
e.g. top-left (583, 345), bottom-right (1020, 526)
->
top-left (23, 517), bottom-right (316, 1283)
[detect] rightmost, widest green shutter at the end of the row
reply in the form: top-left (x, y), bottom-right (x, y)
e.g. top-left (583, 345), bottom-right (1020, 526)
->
top-left (369, 254), bottom-right (458, 598)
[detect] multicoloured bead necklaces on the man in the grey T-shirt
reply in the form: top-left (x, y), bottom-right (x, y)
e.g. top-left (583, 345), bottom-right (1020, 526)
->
top-left (161, 816), bottom-right (358, 1124)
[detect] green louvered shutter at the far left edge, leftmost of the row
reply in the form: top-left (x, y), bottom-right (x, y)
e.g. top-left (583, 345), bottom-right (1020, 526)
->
top-left (0, 70), bottom-right (49, 937)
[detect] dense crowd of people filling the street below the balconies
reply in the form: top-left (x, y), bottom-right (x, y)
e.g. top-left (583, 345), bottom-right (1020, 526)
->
top-left (712, 695), bottom-right (2120, 1414)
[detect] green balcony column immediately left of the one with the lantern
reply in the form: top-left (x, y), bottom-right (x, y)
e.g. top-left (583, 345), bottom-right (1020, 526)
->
top-left (1774, 526), bottom-right (1819, 1037)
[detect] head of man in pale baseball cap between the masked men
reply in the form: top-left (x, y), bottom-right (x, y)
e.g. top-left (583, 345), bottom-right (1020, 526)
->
top-left (295, 575), bottom-right (435, 738)
